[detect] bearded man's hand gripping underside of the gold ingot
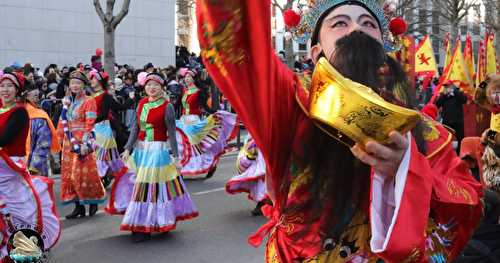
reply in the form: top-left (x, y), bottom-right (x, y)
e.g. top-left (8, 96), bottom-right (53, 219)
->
top-left (351, 131), bottom-right (409, 177)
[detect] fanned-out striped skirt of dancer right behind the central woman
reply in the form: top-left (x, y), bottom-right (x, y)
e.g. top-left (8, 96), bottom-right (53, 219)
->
top-left (177, 111), bottom-right (237, 176)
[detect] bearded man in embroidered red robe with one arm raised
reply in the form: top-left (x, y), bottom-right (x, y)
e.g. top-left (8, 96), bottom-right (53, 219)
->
top-left (197, 0), bottom-right (482, 263)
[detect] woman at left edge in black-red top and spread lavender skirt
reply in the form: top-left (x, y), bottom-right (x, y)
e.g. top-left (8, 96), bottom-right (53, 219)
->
top-left (0, 73), bottom-right (61, 262)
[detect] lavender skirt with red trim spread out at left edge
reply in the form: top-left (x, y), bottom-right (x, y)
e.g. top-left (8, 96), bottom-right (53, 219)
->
top-left (0, 151), bottom-right (61, 261)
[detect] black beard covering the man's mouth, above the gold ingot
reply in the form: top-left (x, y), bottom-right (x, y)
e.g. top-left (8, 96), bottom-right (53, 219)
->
top-left (328, 31), bottom-right (386, 93)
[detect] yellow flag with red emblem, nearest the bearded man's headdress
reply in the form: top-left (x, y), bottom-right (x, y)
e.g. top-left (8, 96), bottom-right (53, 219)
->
top-left (415, 36), bottom-right (437, 75)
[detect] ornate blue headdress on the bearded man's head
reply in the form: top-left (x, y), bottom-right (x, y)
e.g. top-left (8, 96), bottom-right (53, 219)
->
top-left (290, 0), bottom-right (394, 51)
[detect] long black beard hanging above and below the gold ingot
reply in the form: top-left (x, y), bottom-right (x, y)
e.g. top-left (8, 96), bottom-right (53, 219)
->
top-left (283, 31), bottom-right (425, 248)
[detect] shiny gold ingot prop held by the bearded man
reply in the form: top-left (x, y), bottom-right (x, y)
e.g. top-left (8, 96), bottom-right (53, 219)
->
top-left (309, 58), bottom-right (421, 147)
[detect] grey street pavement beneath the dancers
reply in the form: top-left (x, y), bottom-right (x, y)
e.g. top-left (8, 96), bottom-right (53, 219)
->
top-left (49, 153), bottom-right (266, 263)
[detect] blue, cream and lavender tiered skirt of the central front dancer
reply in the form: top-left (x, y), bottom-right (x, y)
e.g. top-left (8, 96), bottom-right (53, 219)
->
top-left (120, 141), bottom-right (198, 233)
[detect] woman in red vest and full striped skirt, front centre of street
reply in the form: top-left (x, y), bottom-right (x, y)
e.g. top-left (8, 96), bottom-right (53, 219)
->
top-left (120, 73), bottom-right (198, 242)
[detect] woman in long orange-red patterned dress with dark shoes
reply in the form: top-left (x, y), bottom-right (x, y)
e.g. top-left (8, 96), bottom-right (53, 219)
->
top-left (58, 70), bottom-right (106, 219)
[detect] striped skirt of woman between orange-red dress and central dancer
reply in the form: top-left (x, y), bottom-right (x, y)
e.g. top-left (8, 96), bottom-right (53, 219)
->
top-left (94, 120), bottom-right (125, 178)
